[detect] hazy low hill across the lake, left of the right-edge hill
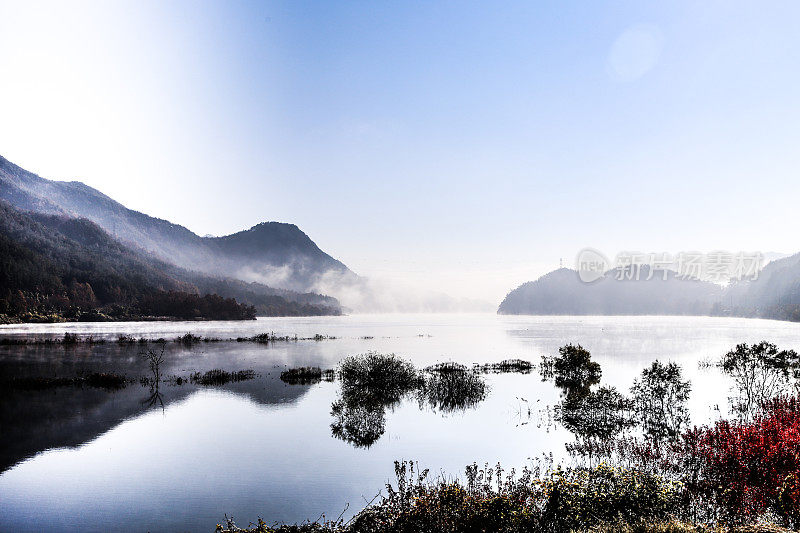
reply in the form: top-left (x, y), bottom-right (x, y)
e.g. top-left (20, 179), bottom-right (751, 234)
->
top-left (497, 266), bottom-right (722, 315)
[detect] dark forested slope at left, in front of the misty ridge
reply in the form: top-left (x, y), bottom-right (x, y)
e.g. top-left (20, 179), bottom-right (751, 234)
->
top-left (0, 201), bottom-right (339, 320)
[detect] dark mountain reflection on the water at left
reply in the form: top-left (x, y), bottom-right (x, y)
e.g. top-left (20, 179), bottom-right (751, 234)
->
top-left (0, 345), bottom-right (316, 471)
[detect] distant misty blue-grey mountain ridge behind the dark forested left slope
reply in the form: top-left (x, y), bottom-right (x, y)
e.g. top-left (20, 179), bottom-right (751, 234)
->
top-left (0, 156), bottom-right (358, 292)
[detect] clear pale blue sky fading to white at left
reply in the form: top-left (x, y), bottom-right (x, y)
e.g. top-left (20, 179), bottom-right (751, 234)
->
top-left (0, 0), bottom-right (800, 304)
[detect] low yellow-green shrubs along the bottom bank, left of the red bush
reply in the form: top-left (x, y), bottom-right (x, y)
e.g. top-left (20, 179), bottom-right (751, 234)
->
top-left (217, 461), bottom-right (790, 533)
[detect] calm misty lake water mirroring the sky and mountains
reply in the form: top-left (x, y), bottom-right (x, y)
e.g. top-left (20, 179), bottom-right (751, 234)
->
top-left (0, 314), bottom-right (800, 531)
